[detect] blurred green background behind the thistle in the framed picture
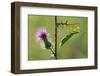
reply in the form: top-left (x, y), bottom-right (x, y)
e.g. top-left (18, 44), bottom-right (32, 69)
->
top-left (28, 15), bottom-right (88, 60)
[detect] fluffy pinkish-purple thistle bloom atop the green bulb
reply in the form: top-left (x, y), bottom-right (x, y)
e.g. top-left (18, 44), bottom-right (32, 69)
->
top-left (36, 28), bottom-right (48, 40)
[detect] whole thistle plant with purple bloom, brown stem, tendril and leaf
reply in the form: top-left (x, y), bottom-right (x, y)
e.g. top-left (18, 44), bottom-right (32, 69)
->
top-left (36, 16), bottom-right (80, 59)
